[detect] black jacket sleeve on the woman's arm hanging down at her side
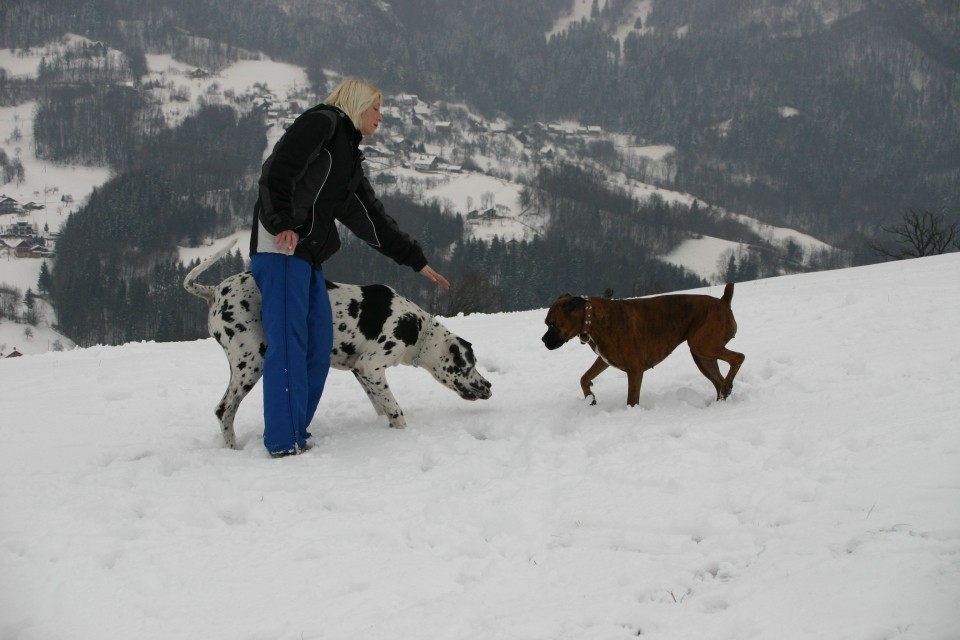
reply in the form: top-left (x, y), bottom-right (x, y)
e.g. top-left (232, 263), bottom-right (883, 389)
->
top-left (259, 111), bottom-right (336, 235)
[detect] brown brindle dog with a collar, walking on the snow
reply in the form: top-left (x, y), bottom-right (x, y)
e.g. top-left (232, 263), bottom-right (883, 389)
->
top-left (543, 283), bottom-right (745, 406)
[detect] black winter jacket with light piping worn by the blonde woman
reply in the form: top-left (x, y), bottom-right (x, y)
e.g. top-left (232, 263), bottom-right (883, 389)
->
top-left (250, 104), bottom-right (427, 271)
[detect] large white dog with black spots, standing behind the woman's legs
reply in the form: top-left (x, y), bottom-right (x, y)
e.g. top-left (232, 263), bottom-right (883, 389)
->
top-left (183, 242), bottom-right (491, 449)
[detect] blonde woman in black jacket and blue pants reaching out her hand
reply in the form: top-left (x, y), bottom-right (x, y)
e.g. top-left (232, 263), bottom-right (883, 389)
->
top-left (250, 80), bottom-right (450, 457)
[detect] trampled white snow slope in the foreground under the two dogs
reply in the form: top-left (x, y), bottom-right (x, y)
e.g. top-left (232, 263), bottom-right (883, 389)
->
top-left (0, 248), bottom-right (960, 640)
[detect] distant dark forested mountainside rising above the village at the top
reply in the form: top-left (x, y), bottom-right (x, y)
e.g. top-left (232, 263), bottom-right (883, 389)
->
top-left (0, 0), bottom-right (960, 242)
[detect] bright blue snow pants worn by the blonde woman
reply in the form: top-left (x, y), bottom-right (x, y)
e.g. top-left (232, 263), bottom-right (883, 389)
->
top-left (251, 253), bottom-right (333, 453)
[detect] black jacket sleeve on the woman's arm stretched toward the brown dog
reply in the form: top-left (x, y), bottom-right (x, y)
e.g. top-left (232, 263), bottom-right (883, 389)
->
top-left (337, 176), bottom-right (427, 272)
